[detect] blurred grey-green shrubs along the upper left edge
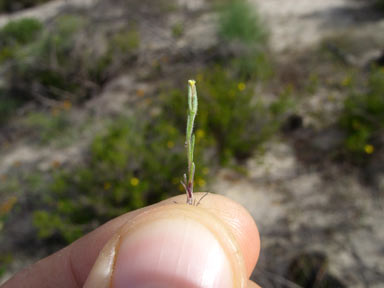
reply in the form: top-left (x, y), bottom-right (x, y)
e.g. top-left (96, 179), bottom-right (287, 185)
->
top-left (0, 15), bottom-right (140, 123)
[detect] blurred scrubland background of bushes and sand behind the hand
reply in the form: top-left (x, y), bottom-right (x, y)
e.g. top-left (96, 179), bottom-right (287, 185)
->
top-left (0, 0), bottom-right (384, 288)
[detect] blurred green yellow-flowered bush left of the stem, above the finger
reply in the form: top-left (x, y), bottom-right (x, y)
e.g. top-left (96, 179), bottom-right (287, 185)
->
top-left (34, 119), bottom-right (208, 242)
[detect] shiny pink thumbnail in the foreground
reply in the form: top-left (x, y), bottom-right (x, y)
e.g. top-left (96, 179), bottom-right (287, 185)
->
top-left (113, 215), bottom-right (233, 288)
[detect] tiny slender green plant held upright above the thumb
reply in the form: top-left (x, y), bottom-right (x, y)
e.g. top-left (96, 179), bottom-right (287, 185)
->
top-left (182, 80), bottom-right (198, 205)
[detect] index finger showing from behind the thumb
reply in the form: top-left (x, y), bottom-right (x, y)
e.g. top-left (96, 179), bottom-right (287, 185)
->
top-left (2, 193), bottom-right (260, 288)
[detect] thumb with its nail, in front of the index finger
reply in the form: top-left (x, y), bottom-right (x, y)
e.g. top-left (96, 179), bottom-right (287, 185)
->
top-left (84, 204), bottom-right (248, 288)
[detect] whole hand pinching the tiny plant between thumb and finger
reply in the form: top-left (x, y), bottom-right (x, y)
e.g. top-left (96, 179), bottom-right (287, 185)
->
top-left (2, 193), bottom-right (260, 288)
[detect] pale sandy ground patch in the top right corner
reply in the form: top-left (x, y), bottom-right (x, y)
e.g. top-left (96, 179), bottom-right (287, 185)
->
top-left (250, 0), bottom-right (384, 53)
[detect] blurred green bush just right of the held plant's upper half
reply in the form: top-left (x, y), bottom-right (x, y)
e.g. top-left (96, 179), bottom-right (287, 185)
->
top-left (162, 66), bottom-right (289, 164)
